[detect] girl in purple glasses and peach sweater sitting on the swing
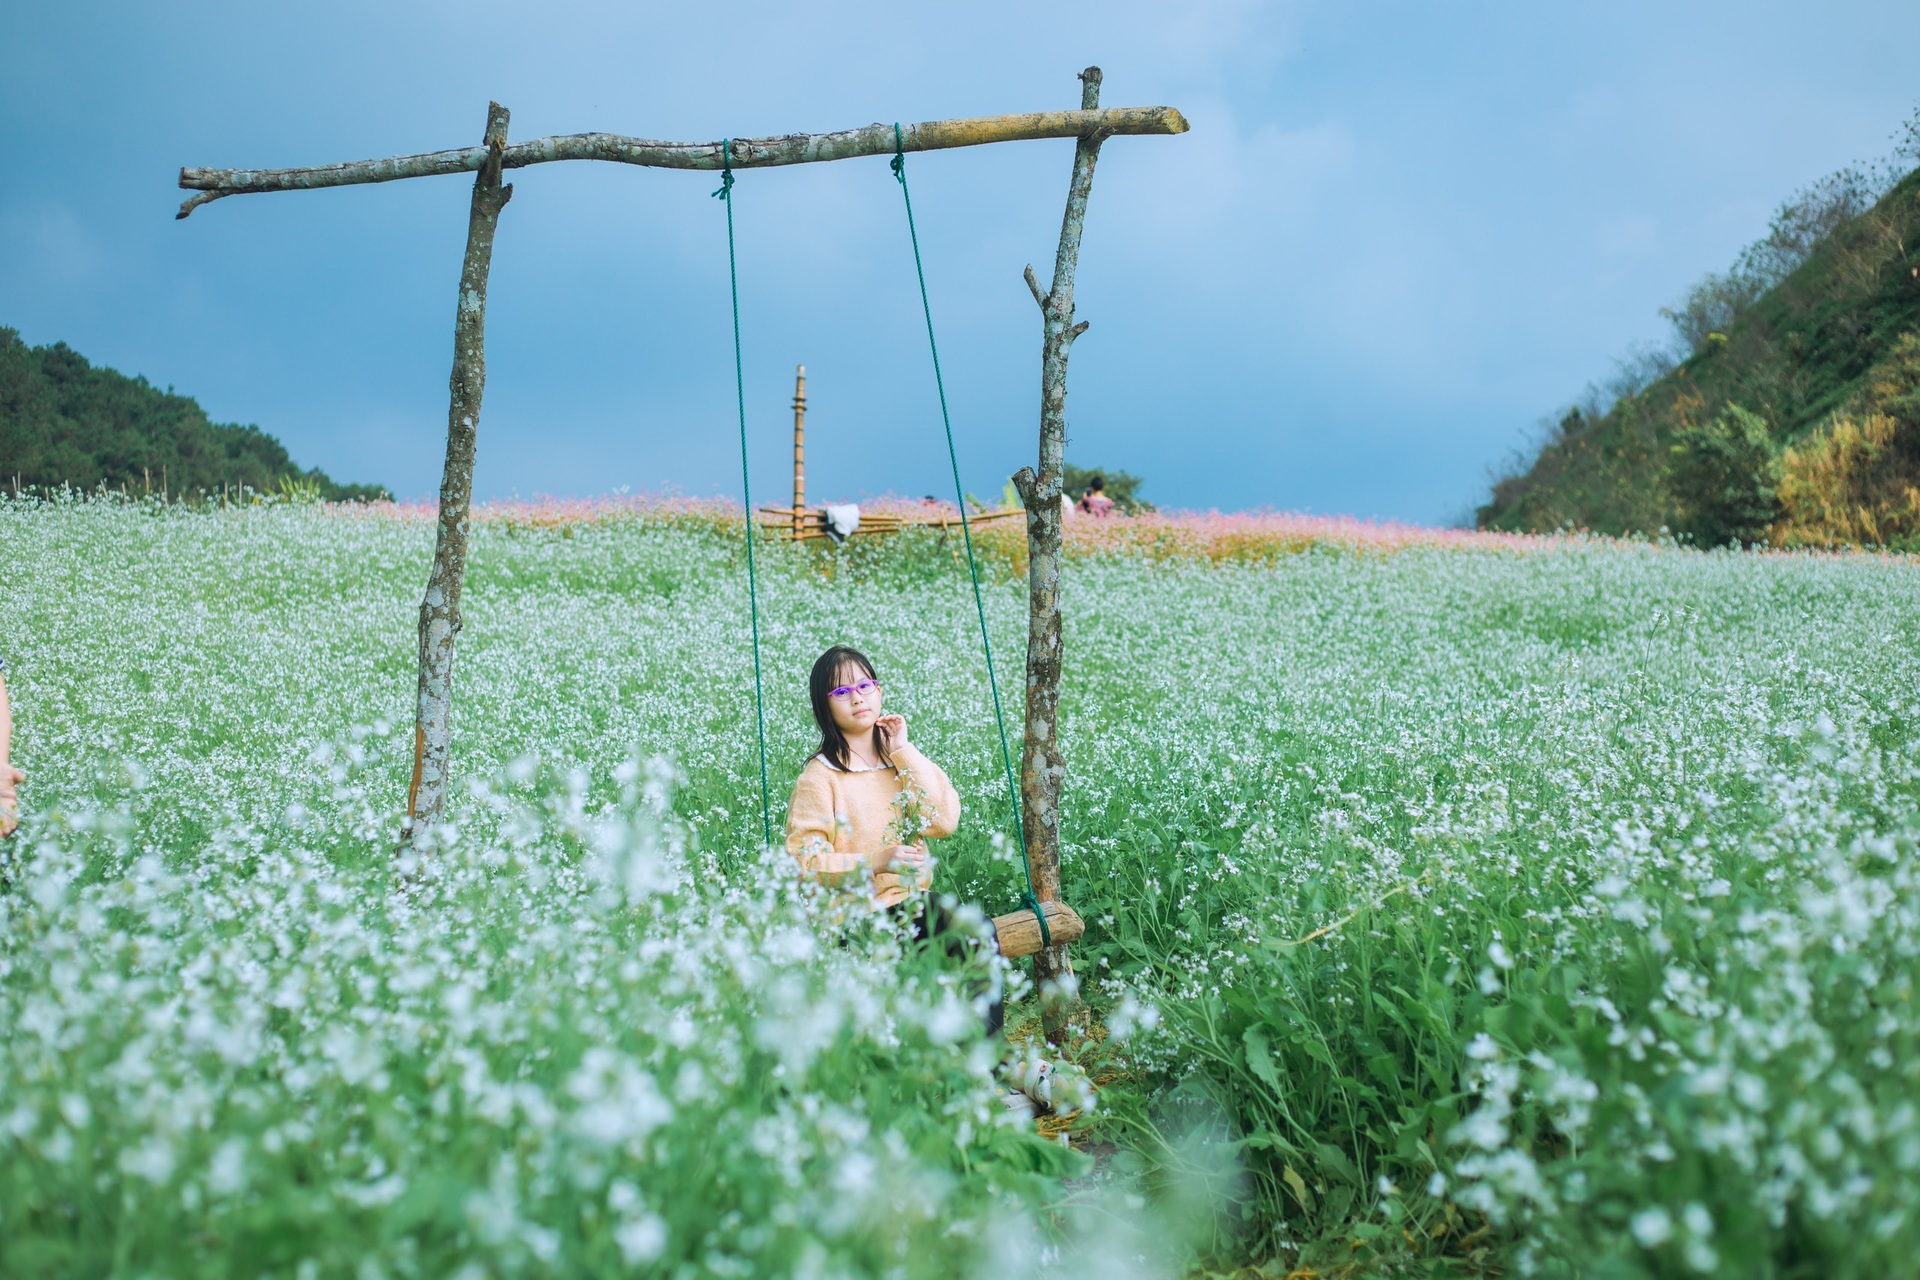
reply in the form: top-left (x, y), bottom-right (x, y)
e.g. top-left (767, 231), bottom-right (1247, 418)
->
top-left (787, 645), bottom-right (960, 908)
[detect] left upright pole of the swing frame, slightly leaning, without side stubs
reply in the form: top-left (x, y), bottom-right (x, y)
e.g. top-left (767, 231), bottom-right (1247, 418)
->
top-left (405, 102), bottom-right (513, 842)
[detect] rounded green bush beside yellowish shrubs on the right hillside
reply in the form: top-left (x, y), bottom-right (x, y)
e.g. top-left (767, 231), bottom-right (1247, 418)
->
top-left (1667, 405), bottom-right (1780, 547)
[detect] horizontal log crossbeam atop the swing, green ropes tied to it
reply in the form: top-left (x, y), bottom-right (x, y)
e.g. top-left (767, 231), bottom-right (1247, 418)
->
top-left (177, 107), bottom-right (1187, 217)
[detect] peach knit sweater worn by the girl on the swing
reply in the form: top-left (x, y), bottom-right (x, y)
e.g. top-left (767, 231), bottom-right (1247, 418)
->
top-left (787, 747), bottom-right (960, 906)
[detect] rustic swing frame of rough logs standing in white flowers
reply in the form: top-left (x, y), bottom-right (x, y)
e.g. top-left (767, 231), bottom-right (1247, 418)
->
top-left (175, 67), bottom-right (1187, 1013)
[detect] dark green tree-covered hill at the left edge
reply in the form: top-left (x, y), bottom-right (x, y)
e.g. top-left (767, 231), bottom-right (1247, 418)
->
top-left (0, 328), bottom-right (386, 501)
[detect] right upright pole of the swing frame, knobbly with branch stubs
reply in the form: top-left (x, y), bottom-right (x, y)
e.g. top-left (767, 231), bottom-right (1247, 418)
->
top-left (1014, 67), bottom-right (1108, 1040)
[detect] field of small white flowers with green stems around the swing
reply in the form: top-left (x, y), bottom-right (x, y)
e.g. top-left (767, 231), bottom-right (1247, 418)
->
top-left (0, 499), bottom-right (1920, 1280)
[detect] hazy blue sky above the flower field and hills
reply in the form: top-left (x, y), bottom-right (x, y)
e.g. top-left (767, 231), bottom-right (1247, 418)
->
top-left (0, 0), bottom-right (1920, 520)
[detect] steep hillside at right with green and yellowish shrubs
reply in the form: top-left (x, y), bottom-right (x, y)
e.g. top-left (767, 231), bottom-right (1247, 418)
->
top-left (1478, 147), bottom-right (1920, 545)
